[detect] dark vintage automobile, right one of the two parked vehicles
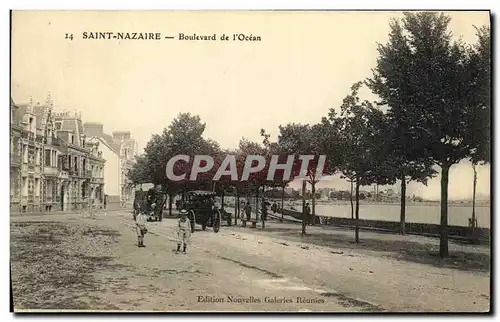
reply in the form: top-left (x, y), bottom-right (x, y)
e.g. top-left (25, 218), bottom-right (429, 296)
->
top-left (183, 190), bottom-right (231, 233)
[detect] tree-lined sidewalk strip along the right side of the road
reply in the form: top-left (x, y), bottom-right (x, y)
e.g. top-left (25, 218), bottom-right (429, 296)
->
top-left (228, 209), bottom-right (491, 272)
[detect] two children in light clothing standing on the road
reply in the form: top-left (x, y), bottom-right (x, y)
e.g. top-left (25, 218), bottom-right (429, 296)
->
top-left (135, 209), bottom-right (191, 254)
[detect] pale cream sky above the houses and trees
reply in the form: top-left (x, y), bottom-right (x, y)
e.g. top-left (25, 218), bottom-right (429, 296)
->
top-left (11, 11), bottom-right (490, 199)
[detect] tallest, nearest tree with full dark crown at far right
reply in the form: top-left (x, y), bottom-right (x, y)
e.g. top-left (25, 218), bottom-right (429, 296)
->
top-left (370, 12), bottom-right (489, 257)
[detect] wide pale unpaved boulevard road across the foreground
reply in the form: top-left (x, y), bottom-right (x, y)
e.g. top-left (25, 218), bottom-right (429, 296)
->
top-left (11, 212), bottom-right (490, 312)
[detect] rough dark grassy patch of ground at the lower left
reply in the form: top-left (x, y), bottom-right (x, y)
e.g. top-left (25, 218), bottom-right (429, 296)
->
top-left (11, 221), bottom-right (125, 310)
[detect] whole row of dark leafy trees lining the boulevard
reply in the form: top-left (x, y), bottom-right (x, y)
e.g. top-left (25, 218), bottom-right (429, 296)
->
top-left (130, 12), bottom-right (491, 257)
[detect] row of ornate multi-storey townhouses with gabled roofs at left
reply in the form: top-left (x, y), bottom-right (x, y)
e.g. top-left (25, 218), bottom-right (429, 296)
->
top-left (10, 96), bottom-right (105, 213)
